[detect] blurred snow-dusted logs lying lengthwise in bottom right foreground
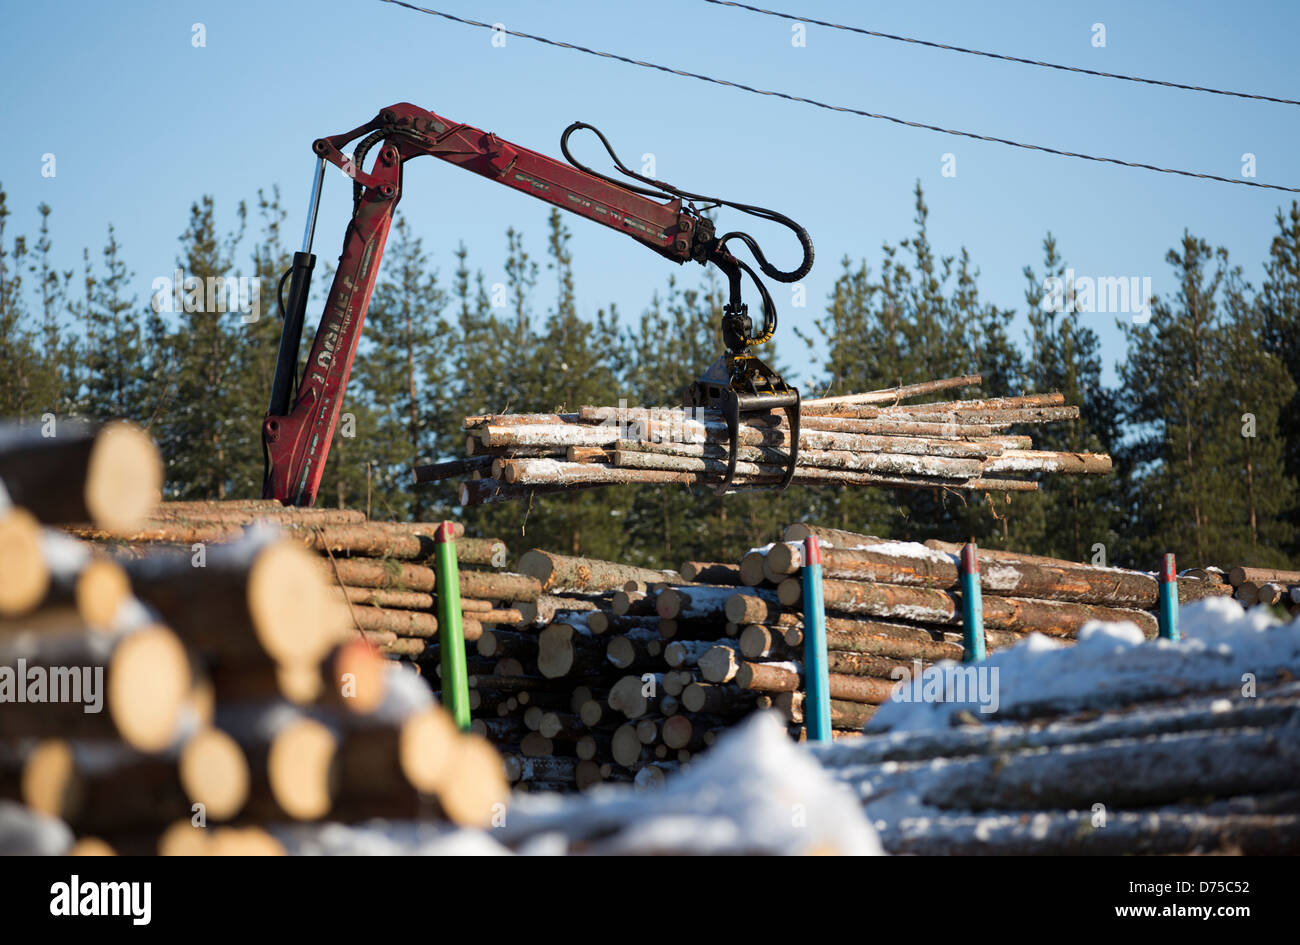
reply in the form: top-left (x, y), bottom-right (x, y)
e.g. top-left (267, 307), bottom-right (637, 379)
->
top-left (816, 673), bottom-right (1300, 855)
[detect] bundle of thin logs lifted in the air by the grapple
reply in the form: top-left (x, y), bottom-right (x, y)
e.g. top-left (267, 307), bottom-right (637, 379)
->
top-left (413, 376), bottom-right (1110, 506)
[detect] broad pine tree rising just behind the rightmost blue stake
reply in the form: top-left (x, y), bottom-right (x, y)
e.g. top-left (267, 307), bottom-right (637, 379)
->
top-left (1121, 234), bottom-right (1294, 567)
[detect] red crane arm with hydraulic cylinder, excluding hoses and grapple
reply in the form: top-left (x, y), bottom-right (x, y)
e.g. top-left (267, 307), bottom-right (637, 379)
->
top-left (263, 103), bottom-right (712, 506)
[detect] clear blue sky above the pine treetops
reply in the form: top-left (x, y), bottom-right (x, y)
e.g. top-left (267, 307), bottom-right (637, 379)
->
top-left (0, 0), bottom-right (1300, 392)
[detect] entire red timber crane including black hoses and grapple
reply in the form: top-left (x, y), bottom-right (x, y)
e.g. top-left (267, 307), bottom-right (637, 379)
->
top-left (263, 103), bottom-right (813, 506)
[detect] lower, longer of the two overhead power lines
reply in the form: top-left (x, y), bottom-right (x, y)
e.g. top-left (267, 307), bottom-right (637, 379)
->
top-left (381, 0), bottom-right (1300, 194)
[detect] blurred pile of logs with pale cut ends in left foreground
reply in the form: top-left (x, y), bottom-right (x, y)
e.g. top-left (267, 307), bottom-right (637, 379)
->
top-left (0, 425), bottom-right (507, 854)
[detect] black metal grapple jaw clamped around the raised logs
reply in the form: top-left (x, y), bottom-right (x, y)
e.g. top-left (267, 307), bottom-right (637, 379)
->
top-left (685, 354), bottom-right (800, 493)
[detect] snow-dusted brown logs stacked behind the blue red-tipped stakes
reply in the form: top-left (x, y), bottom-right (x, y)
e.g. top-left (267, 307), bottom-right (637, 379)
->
top-left (710, 523), bottom-right (1232, 731)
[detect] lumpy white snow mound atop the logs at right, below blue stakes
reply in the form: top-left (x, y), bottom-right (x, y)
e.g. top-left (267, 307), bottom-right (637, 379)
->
top-left (867, 597), bottom-right (1300, 733)
